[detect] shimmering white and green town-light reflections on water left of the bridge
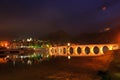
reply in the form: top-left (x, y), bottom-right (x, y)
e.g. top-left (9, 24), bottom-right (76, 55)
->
top-left (6, 52), bottom-right (50, 64)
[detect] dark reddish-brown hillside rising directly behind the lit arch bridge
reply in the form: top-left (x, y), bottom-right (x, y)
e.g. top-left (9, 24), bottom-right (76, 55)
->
top-left (40, 27), bottom-right (120, 44)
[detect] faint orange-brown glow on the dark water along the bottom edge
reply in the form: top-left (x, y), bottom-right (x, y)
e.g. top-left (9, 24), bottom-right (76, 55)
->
top-left (48, 72), bottom-right (99, 80)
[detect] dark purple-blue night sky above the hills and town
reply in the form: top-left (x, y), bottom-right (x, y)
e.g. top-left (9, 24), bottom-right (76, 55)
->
top-left (0, 0), bottom-right (120, 39)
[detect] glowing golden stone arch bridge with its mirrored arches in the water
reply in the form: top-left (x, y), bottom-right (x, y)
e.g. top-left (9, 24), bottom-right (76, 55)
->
top-left (49, 44), bottom-right (120, 56)
